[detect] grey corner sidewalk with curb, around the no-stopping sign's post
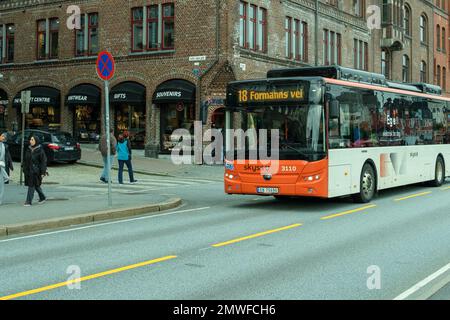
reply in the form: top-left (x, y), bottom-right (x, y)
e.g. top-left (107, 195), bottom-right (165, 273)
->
top-left (0, 183), bottom-right (181, 237)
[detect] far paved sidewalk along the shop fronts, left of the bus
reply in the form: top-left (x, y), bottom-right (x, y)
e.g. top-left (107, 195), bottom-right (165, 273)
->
top-left (78, 144), bottom-right (224, 181)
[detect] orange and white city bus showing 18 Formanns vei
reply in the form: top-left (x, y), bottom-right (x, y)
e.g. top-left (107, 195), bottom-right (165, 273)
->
top-left (225, 66), bottom-right (450, 202)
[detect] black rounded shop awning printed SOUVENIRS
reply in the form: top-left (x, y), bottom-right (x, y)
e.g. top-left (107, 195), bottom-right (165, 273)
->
top-left (153, 79), bottom-right (196, 103)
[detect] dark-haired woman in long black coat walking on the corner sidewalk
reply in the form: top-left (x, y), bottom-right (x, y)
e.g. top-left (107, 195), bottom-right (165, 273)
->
top-left (23, 136), bottom-right (47, 207)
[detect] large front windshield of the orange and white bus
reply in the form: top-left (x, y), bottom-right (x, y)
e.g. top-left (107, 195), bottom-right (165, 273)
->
top-left (236, 104), bottom-right (326, 161)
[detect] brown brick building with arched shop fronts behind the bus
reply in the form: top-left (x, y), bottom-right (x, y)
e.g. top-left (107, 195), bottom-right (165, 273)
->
top-left (0, 0), bottom-right (448, 156)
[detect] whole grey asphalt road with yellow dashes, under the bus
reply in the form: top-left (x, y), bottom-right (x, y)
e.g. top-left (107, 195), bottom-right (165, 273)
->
top-left (0, 174), bottom-right (450, 299)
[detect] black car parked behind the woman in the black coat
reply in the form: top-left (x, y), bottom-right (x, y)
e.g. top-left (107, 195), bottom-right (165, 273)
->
top-left (7, 129), bottom-right (81, 163)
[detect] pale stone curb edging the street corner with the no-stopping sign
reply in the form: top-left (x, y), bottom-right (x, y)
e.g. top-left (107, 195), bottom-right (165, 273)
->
top-left (0, 198), bottom-right (182, 237)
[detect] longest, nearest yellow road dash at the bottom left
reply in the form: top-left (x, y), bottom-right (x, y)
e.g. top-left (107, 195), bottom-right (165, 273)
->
top-left (0, 256), bottom-right (177, 300)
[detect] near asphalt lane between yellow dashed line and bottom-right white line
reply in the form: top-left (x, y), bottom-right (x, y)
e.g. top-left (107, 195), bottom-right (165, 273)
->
top-left (15, 188), bottom-right (450, 299)
